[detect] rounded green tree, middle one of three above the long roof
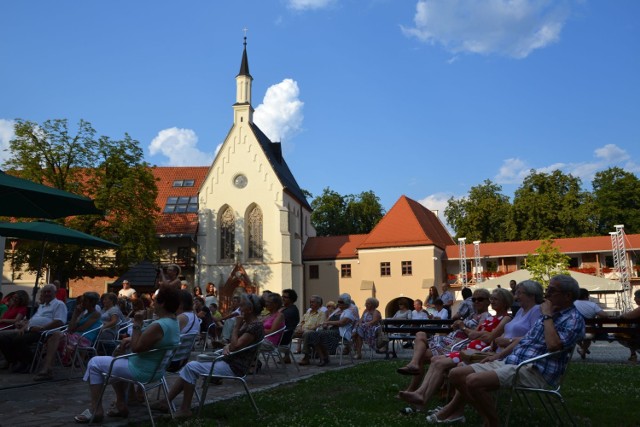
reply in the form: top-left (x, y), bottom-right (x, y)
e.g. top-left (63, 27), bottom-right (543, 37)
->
top-left (509, 170), bottom-right (596, 240)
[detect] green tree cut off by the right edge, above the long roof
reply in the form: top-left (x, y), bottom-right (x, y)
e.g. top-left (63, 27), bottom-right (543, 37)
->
top-left (591, 167), bottom-right (640, 235)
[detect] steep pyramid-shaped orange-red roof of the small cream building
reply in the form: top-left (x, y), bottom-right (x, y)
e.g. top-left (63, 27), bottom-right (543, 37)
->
top-left (358, 195), bottom-right (454, 249)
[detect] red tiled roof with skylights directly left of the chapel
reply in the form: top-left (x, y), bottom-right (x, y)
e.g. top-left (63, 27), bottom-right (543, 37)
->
top-left (151, 166), bottom-right (209, 234)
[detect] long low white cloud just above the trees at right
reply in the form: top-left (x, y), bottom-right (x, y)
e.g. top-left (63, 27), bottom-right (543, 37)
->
top-left (494, 144), bottom-right (640, 185)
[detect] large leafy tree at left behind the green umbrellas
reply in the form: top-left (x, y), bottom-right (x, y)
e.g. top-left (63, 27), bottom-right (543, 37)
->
top-left (4, 119), bottom-right (158, 280)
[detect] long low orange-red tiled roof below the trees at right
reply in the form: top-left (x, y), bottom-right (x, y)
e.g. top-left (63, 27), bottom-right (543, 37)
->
top-left (446, 234), bottom-right (640, 259)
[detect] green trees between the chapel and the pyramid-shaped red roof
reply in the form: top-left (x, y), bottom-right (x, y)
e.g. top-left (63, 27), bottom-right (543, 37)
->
top-left (311, 187), bottom-right (384, 236)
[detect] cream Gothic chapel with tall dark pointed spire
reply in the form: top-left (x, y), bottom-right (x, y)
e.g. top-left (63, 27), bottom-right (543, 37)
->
top-left (196, 38), bottom-right (315, 304)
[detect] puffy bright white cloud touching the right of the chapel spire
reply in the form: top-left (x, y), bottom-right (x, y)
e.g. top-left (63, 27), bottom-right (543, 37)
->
top-left (253, 79), bottom-right (304, 145)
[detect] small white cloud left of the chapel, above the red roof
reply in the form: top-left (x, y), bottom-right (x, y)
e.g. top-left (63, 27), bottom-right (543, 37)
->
top-left (149, 127), bottom-right (213, 166)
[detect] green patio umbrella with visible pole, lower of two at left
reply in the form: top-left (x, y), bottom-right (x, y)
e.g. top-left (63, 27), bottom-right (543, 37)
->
top-left (0, 220), bottom-right (119, 314)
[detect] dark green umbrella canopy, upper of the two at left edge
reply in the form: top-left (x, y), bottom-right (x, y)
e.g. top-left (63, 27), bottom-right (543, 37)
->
top-left (0, 171), bottom-right (103, 219)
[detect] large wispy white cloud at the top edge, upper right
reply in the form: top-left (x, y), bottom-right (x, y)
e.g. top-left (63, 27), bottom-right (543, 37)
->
top-left (402, 0), bottom-right (569, 58)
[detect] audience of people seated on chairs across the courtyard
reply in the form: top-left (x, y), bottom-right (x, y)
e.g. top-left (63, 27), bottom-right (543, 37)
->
top-left (0, 272), bottom-right (600, 426)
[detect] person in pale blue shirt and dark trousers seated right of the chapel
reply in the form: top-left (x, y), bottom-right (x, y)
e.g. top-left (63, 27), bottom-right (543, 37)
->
top-left (308, 294), bottom-right (358, 366)
